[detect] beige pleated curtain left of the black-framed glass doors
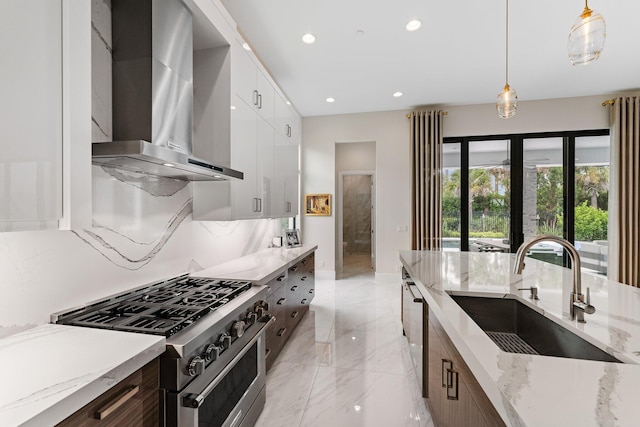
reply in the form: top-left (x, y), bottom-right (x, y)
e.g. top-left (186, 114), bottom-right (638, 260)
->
top-left (409, 110), bottom-right (445, 250)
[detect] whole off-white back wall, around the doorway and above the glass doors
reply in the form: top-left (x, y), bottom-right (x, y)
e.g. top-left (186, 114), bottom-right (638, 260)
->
top-left (302, 93), bottom-right (631, 276)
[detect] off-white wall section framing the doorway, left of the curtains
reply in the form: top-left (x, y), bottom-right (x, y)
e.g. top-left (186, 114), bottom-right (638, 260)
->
top-left (301, 111), bottom-right (411, 276)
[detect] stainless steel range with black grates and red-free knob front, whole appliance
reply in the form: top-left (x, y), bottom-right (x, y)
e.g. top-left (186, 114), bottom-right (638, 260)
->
top-left (51, 274), bottom-right (274, 427)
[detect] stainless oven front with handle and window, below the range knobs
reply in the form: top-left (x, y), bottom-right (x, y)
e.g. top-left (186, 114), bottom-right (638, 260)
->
top-left (165, 322), bottom-right (270, 427)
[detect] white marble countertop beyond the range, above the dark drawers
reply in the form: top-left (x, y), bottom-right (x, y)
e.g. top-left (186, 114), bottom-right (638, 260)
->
top-left (192, 245), bottom-right (318, 285)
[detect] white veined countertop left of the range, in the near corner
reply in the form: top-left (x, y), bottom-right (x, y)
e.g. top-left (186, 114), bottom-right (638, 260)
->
top-left (0, 324), bottom-right (165, 427)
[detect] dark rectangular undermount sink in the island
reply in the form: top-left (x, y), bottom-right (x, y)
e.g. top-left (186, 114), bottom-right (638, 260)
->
top-left (450, 294), bottom-right (622, 363)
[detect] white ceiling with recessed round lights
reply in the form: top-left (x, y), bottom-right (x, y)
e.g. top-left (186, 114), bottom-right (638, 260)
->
top-left (222, 0), bottom-right (640, 116)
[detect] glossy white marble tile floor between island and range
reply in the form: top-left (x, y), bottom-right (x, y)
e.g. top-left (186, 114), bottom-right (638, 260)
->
top-left (256, 270), bottom-right (433, 427)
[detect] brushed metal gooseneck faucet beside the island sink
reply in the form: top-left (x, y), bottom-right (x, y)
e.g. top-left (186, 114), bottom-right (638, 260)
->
top-left (513, 235), bottom-right (596, 323)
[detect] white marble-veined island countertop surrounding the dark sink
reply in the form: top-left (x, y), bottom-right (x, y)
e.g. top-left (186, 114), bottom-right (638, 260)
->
top-left (400, 251), bottom-right (640, 426)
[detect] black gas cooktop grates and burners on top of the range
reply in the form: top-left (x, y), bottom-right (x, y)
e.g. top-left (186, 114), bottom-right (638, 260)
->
top-left (56, 275), bottom-right (251, 337)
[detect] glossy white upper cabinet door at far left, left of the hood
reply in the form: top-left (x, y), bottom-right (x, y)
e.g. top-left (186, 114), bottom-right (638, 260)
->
top-left (0, 0), bottom-right (62, 230)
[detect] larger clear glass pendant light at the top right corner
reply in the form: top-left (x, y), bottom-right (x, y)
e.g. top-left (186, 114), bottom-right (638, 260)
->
top-left (567, 0), bottom-right (607, 65)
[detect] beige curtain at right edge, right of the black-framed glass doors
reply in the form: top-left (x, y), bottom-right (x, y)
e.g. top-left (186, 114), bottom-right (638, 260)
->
top-left (608, 96), bottom-right (640, 287)
